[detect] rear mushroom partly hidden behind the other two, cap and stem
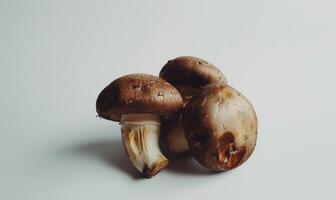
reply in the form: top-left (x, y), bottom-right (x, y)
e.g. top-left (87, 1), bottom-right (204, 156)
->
top-left (159, 56), bottom-right (227, 154)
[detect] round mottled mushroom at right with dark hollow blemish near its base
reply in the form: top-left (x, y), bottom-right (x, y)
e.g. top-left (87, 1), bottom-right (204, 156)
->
top-left (182, 84), bottom-right (257, 171)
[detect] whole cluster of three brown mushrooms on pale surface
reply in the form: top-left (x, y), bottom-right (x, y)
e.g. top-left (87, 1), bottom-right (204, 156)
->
top-left (96, 56), bottom-right (257, 178)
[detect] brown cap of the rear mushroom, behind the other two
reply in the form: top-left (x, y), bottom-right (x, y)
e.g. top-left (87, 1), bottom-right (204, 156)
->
top-left (160, 56), bottom-right (227, 88)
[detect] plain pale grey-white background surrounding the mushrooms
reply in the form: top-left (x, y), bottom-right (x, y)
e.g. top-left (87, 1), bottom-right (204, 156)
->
top-left (0, 0), bottom-right (336, 200)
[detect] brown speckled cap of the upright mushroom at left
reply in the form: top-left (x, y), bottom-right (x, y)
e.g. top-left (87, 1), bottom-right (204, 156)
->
top-left (96, 74), bottom-right (183, 121)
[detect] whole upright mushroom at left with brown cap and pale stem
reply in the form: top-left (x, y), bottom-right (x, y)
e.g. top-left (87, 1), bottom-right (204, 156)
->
top-left (96, 74), bottom-right (183, 178)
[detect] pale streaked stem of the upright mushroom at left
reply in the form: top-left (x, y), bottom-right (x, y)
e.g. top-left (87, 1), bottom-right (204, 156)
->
top-left (120, 114), bottom-right (168, 178)
